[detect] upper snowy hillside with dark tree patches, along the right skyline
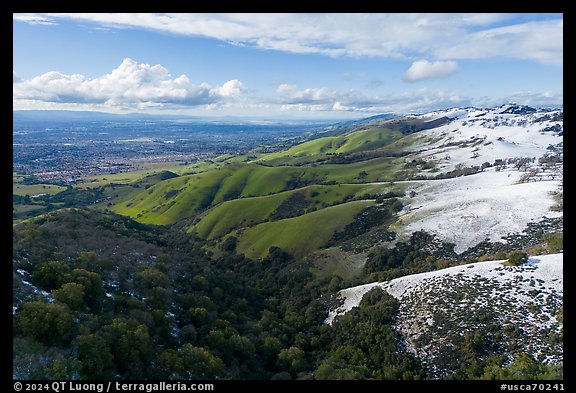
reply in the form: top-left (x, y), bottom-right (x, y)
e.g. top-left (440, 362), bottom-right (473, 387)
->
top-left (416, 105), bottom-right (564, 175)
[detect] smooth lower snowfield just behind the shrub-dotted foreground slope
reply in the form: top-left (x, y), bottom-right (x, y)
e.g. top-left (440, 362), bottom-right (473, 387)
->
top-left (395, 171), bottom-right (562, 253)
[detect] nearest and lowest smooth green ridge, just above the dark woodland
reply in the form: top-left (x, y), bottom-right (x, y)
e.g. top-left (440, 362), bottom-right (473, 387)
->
top-left (232, 201), bottom-right (375, 259)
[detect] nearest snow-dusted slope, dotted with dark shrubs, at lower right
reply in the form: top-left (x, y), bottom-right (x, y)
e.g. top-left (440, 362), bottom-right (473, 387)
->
top-left (325, 253), bottom-right (563, 377)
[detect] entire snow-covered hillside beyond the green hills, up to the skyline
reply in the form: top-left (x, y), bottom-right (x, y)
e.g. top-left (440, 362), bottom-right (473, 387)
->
top-left (394, 105), bottom-right (563, 253)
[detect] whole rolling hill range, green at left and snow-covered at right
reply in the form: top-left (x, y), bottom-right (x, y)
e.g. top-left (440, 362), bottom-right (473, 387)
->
top-left (100, 106), bottom-right (562, 264)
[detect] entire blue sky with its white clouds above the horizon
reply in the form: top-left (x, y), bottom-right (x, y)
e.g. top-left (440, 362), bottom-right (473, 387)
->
top-left (13, 13), bottom-right (563, 119)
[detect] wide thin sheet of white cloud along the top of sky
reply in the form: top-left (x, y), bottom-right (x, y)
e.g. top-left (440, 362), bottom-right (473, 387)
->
top-left (14, 13), bottom-right (563, 64)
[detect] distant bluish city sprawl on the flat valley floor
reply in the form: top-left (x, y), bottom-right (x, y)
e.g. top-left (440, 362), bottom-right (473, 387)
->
top-left (13, 112), bottom-right (326, 184)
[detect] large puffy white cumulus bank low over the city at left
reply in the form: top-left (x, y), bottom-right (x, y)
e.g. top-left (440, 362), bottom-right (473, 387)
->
top-left (13, 58), bottom-right (244, 107)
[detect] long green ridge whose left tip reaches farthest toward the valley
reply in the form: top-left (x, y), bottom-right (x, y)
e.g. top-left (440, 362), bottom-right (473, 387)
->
top-left (111, 157), bottom-right (396, 225)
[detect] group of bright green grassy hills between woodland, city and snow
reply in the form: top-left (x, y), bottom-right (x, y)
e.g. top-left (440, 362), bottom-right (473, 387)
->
top-left (98, 113), bottom-right (440, 258)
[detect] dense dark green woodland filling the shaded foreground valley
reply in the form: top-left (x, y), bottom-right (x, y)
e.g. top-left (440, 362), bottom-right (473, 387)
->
top-left (13, 208), bottom-right (562, 380)
